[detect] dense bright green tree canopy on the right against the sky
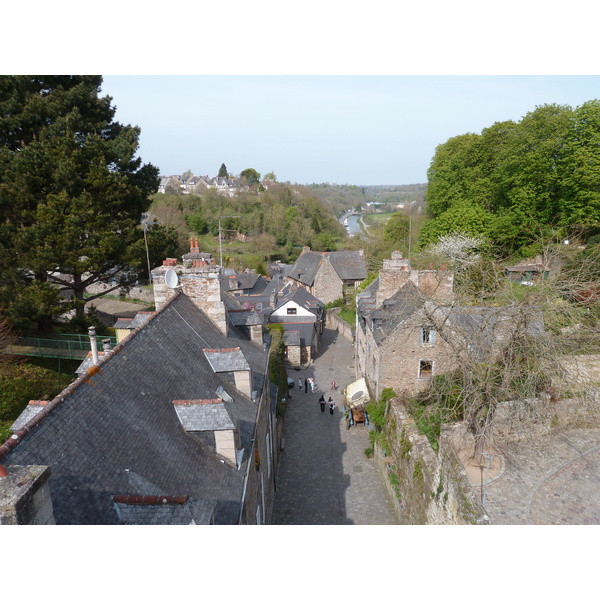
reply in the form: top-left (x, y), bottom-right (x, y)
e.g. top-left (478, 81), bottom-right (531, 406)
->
top-left (421, 100), bottom-right (600, 255)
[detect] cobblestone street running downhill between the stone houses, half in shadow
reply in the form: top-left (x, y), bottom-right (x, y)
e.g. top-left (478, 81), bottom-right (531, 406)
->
top-left (273, 329), bottom-right (395, 525)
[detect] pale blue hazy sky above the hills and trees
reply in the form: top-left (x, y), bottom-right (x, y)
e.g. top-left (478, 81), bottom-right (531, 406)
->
top-left (102, 75), bottom-right (600, 185)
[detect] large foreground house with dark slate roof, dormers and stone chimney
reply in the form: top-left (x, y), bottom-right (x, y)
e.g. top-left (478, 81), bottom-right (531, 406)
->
top-left (0, 282), bottom-right (279, 524)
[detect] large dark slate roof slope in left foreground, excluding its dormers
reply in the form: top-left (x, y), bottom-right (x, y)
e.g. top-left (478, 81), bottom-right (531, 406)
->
top-left (0, 293), bottom-right (268, 524)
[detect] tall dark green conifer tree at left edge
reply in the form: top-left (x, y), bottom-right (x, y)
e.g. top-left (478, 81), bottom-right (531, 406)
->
top-left (0, 76), bottom-right (158, 328)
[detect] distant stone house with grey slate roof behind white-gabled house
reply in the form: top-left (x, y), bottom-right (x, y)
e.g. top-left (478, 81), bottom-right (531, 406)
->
top-left (287, 246), bottom-right (367, 304)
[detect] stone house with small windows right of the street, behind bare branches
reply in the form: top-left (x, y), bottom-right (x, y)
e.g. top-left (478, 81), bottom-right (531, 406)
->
top-left (355, 248), bottom-right (543, 404)
